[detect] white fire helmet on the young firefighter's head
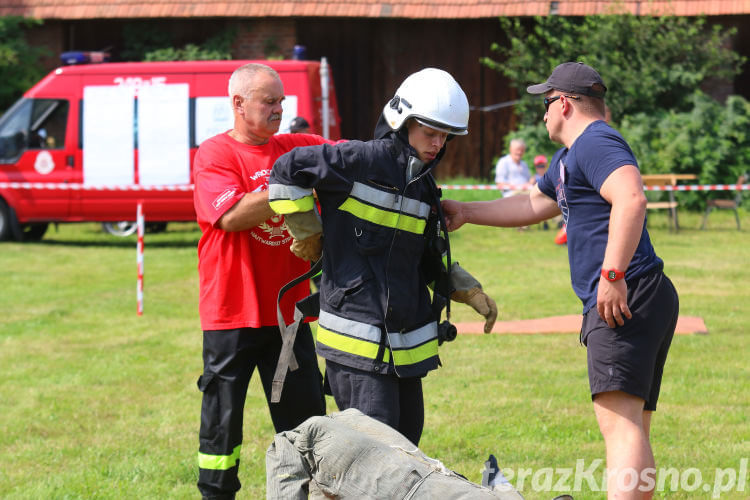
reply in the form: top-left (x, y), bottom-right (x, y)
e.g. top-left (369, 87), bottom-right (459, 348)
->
top-left (383, 68), bottom-right (469, 135)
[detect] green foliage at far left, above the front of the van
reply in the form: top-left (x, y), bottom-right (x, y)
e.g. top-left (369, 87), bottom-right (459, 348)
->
top-left (0, 16), bottom-right (49, 110)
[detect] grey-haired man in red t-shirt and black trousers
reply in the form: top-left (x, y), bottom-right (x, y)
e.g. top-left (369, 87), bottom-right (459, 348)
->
top-left (194, 64), bottom-right (328, 499)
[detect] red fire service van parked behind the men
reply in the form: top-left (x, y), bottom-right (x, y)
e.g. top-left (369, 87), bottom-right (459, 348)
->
top-left (0, 60), bottom-right (341, 240)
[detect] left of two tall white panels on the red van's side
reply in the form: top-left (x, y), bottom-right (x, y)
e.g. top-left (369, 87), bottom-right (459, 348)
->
top-left (83, 85), bottom-right (135, 186)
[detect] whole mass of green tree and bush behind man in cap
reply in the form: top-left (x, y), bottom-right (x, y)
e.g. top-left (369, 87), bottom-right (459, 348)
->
top-left (481, 13), bottom-right (750, 198)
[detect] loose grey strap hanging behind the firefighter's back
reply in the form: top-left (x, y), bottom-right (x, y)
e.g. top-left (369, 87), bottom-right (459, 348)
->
top-left (271, 256), bottom-right (323, 403)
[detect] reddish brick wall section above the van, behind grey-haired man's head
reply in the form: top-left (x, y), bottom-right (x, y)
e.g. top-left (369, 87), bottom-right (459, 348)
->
top-left (232, 18), bottom-right (297, 59)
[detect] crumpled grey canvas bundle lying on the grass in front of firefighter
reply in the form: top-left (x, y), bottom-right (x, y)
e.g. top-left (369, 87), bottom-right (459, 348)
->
top-left (266, 408), bottom-right (523, 500)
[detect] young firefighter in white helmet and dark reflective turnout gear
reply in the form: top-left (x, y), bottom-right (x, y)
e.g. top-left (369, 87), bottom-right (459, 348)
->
top-left (269, 68), bottom-right (497, 444)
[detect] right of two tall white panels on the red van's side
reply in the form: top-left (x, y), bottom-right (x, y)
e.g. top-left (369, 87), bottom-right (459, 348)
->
top-left (138, 83), bottom-right (190, 186)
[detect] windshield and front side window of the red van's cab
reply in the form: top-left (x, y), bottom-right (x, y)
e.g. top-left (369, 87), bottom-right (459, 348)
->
top-left (0, 98), bottom-right (68, 162)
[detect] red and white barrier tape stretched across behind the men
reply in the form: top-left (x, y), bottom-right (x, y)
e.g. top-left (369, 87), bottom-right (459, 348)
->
top-left (0, 182), bottom-right (750, 191)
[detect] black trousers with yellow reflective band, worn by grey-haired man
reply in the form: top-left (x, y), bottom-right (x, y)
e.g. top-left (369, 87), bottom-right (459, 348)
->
top-left (198, 324), bottom-right (325, 498)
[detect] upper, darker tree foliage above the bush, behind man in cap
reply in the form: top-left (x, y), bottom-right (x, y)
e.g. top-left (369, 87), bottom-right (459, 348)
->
top-left (483, 14), bottom-right (743, 124)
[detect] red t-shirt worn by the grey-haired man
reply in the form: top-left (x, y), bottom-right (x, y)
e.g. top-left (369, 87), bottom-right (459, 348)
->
top-left (193, 133), bottom-right (327, 330)
